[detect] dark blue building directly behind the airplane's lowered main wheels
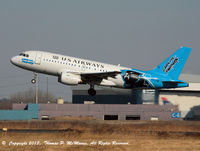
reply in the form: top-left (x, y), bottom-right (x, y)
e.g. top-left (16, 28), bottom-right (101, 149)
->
top-left (72, 86), bottom-right (159, 104)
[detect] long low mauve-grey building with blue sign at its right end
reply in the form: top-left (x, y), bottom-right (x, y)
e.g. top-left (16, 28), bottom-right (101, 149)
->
top-left (13, 104), bottom-right (181, 121)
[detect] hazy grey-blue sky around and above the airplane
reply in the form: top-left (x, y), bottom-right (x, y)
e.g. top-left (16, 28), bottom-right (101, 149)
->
top-left (0, 0), bottom-right (200, 101)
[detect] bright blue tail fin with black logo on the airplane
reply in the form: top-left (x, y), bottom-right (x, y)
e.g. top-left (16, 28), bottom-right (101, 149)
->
top-left (152, 47), bottom-right (192, 80)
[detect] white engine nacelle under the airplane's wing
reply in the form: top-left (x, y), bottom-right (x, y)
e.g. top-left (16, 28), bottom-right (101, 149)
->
top-left (58, 72), bottom-right (82, 85)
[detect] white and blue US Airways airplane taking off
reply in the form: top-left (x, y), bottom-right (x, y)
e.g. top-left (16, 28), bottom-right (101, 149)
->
top-left (10, 47), bottom-right (192, 96)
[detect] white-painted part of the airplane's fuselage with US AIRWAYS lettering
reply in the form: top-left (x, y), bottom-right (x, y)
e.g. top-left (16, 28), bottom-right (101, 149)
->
top-left (11, 51), bottom-right (130, 87)
